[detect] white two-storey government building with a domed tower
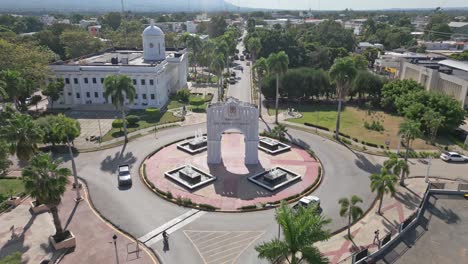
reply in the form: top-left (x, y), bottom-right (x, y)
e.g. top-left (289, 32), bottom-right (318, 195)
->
top-left (50, 21), bottom-right (188, 109)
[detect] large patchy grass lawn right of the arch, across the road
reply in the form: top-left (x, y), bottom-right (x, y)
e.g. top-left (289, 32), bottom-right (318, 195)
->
top-left (268, 104), bottom-right (451, 150)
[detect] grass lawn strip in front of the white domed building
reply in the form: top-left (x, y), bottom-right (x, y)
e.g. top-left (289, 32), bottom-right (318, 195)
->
top-left (102, 110), bottom-right (182, 142)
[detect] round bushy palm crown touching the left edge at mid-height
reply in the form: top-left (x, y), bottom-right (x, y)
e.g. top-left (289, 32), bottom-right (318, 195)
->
top-left (0, 113), bottom-right (44, 161)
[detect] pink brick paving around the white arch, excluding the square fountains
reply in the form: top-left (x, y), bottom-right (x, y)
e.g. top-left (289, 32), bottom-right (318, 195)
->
top-left (146, 134), bottom-right (319, 210)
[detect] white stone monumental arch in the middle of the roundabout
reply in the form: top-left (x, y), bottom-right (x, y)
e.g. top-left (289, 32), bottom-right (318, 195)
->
top-left (207, 97), bottom-right (259, 165)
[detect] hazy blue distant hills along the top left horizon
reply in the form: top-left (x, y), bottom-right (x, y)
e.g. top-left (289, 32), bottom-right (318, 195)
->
top-left (0, 0), bottom-right (238, 12)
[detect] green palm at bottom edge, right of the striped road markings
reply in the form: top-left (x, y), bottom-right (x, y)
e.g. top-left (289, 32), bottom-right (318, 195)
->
top-left (255, 202), bottom-right (331, 264)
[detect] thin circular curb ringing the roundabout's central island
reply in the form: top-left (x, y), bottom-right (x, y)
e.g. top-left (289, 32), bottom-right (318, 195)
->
top-left (138, 134), bottom-right (325, 213)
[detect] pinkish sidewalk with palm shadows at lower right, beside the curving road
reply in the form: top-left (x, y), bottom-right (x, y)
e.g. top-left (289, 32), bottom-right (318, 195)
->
top-left (316, 178), bottom-right (427, 264)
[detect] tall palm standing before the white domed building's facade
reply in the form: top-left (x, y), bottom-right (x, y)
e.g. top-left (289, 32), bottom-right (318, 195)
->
top-left (104, 75), bottom-right (136, 142)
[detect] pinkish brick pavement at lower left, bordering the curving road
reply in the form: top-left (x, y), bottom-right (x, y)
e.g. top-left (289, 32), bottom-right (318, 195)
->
top-left (59, 180), bottom-right (154, 264)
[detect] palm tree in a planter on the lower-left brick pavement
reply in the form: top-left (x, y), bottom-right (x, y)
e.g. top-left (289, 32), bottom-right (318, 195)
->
top-left (22, 153), bottom-right (71, 241)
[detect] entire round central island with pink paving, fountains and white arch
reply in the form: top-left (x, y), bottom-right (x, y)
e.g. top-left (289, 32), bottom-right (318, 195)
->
top-left (144, 98), bottom-right (320, 211)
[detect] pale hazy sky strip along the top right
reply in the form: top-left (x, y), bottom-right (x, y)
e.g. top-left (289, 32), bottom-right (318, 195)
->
top-left (226, 0), bottom-right (468, 10)
